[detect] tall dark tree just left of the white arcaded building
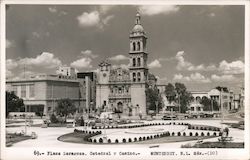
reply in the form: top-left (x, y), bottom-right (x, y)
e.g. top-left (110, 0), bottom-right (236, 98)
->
top-left (175, 83), bottom-right (192, 113)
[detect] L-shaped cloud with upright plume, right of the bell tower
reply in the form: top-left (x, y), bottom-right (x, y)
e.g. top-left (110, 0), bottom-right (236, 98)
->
top-left (175, 51), bottom-right (216, 71)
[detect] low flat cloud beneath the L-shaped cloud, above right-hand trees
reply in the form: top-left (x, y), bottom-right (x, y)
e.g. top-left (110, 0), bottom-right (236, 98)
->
top-left (173, 72), bottom-right (211, 83)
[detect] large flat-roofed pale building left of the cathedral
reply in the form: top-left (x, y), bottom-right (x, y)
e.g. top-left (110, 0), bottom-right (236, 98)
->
top-left (6, 74), bottom-right (81, 115)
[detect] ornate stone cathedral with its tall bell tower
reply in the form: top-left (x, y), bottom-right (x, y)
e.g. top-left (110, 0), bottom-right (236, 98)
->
top-left (96, 13), bottom-right (156, 116)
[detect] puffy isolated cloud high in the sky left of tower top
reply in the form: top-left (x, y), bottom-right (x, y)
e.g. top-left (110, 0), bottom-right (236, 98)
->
top-left (77, 11), bottom-right (114, 28)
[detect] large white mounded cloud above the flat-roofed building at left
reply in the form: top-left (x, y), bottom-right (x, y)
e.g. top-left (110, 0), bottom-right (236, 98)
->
top-left (18, 52), bottom-right (62, 68)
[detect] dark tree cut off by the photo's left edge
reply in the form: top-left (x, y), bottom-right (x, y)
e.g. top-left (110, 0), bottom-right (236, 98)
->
top-left (5, 91), bottom-right (25, 117)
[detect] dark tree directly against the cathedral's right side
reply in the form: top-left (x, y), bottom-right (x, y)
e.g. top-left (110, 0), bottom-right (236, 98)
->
top-left (146, 87), bottom-right (163, 111)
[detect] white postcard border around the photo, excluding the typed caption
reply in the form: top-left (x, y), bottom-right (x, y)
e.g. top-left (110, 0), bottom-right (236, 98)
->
top-left (0, 0), bottom-right (250, 160)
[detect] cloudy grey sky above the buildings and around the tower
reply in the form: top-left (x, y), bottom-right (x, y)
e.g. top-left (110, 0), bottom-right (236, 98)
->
top-left (6, 5), bottom-right (245, 92)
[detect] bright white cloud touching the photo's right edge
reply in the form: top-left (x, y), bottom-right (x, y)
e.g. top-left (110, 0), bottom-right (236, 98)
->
top-left (219, 60), bottom-right (244, 74)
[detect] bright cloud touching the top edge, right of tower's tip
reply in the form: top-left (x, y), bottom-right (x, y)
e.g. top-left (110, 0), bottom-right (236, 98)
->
top-left (139, 5), bottom-right (179, 16)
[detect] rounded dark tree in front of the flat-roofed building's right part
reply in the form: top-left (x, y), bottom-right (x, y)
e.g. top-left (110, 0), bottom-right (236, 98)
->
top-left (56, 98), bottom-right (76, 122)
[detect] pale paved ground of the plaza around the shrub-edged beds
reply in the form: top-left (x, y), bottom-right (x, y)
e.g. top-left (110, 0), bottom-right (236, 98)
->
top-left (6, 120), bottom-right (244, 148)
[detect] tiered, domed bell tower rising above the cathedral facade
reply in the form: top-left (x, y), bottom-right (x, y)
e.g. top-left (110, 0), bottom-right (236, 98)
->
top-left (129, 13), bottom-right (148, 83)
